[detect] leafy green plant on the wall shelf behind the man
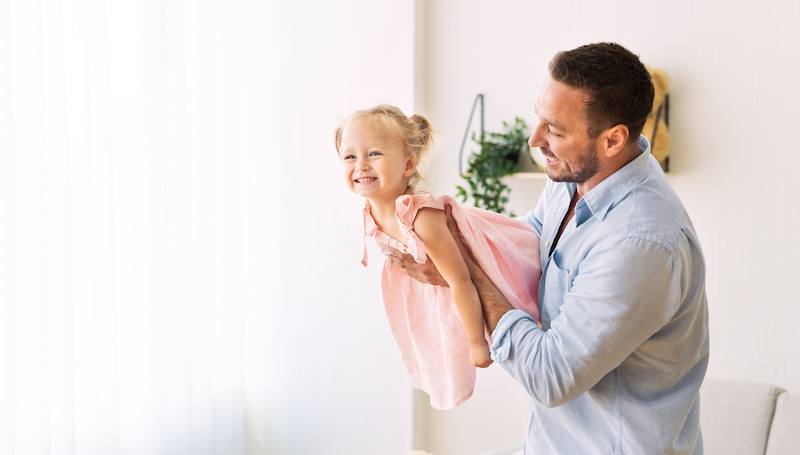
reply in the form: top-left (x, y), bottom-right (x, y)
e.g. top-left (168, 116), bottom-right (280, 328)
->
top-left (456, 117), bottom-right (528, 216)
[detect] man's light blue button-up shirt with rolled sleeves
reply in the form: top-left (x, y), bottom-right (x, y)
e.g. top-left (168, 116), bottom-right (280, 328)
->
top-left (492, 138), bottom-right (708, 455)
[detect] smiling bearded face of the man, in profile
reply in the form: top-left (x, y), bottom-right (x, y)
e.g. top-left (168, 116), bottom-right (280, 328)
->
top-left (528, 78), bottom-right (599, 183)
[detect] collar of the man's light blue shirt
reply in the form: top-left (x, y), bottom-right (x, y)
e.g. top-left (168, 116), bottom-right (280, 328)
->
top-left (576, 135), bottom-right (650, 222)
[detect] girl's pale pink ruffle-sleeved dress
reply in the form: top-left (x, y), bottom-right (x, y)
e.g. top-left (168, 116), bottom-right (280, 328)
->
top-left (362, 193), bottom-right (541, 409)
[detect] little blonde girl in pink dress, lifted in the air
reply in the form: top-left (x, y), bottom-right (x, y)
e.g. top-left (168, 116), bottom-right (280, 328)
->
top-left (335, 105), bottom-right (541, 409)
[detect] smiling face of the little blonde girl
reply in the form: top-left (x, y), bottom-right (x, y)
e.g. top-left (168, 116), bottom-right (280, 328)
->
top-left (339, 117), bottom-right (416, 201)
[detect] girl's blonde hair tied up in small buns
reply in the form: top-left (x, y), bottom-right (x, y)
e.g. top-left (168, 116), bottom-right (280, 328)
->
top-left (334, 104), bottom-right (433, 188)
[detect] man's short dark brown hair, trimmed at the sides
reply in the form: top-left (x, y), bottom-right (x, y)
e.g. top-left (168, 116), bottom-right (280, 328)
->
top-left (550, 43), bottom-right (653, 143)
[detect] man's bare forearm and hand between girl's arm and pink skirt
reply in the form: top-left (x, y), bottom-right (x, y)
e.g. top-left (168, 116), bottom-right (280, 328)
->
top-left (444, 205), bottom-right (514, 334)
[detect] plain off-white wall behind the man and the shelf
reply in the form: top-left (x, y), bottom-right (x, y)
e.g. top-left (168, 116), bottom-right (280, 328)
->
top-left (417, 0), bottom-right (800, 455)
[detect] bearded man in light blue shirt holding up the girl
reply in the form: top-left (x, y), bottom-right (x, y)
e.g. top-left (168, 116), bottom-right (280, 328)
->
top-left (392, 43), bottom-right (708, 455)
